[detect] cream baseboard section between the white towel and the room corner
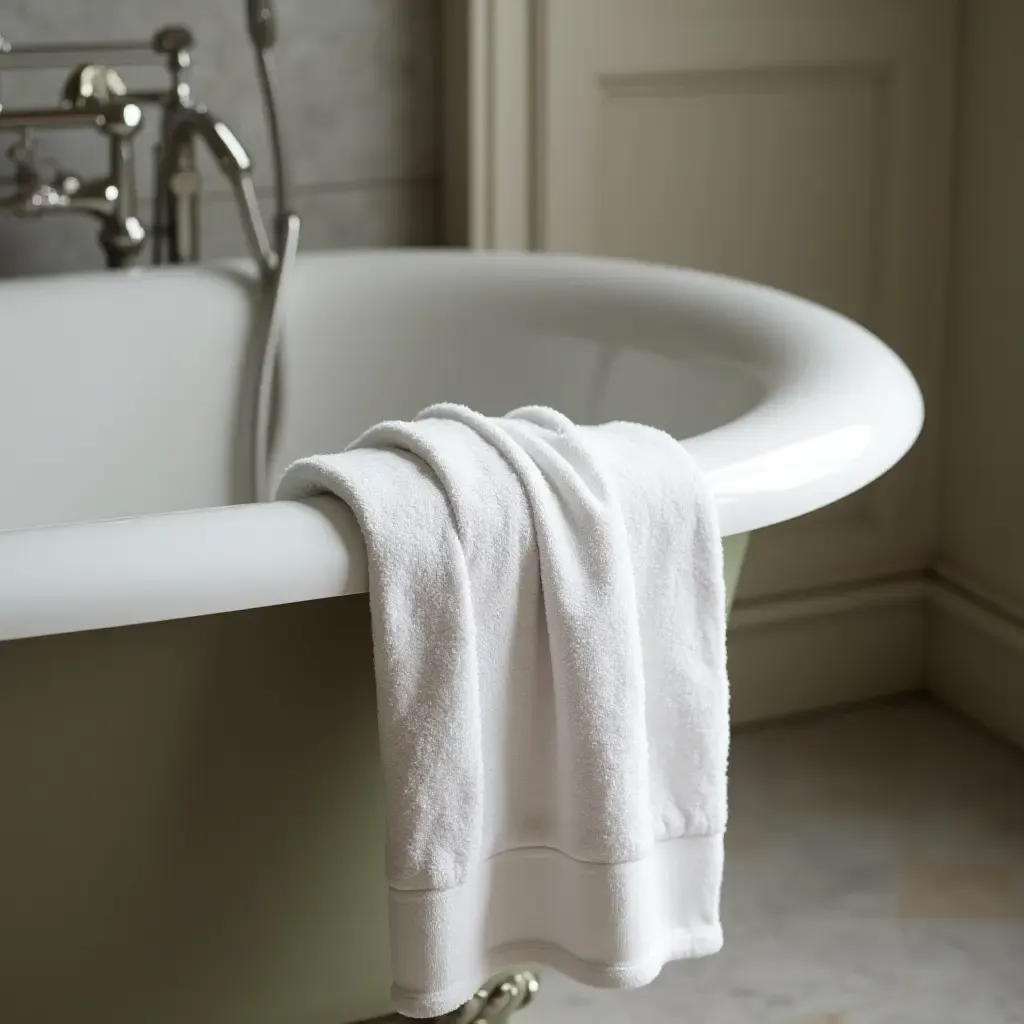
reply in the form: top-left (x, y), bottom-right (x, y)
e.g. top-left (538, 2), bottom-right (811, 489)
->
top-left (729, 575), bottom-right (927, 723)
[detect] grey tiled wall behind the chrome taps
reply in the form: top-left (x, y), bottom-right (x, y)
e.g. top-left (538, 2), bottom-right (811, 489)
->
top-left (0, 0), bottom-right (440, 276)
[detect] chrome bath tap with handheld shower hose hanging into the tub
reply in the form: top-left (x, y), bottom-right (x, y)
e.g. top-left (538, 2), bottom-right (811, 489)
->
top-left (0, 9), bottom-right (300, 501)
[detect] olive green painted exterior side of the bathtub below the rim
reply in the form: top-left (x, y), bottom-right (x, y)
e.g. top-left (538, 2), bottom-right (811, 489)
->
top-left (0, 537), bottom-right (748, 1024)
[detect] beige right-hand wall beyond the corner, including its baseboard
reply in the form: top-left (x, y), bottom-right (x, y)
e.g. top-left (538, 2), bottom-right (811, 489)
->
top-left (930, 0), bottom-right (1024, 741)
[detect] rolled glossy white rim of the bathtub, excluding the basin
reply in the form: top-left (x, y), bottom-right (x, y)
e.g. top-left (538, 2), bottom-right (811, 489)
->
top-left (0, 250), bottom-right (924, 640)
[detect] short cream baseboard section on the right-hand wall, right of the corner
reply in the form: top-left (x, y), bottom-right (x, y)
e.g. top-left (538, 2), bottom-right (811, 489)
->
top-left (927, 570), bottom-right (1024, 746)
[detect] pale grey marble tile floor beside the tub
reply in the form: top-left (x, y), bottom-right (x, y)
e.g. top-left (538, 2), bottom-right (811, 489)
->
top-left (516, 698), bottom-right (1024, 1024)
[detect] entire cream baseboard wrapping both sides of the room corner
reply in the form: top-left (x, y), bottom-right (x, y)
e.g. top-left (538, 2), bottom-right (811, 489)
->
top-left (729, 567), bottom-right (1024, 746)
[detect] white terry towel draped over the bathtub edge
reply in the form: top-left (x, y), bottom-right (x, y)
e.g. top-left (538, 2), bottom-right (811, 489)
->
top-left (278, 404), bottom-right (728, 1017)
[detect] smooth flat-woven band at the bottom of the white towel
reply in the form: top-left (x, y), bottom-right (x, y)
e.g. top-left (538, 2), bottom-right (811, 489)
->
top-left (390, 834), bottom-right (724, 1018)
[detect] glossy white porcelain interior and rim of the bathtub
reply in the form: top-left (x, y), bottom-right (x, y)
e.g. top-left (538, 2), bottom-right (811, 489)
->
top-left (0, 250), bottom-right (924, 638)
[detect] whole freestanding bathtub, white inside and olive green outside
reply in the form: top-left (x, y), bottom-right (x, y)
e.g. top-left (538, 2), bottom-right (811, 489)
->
top-left (0, 251), bottom-right (923, 1024)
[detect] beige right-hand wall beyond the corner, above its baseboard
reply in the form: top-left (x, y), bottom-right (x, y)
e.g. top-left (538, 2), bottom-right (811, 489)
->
top-left (942, 0), bottom-right (1024, 608)
